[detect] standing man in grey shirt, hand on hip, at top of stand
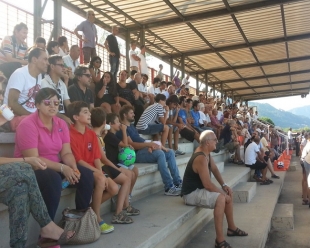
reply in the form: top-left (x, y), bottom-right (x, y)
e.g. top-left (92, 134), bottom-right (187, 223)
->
top-left (74, 10), bottom-right (98, 65)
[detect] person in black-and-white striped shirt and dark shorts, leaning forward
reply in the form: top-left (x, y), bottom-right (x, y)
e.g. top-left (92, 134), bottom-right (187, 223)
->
top-left (137, 94), bottom-right (169, 146)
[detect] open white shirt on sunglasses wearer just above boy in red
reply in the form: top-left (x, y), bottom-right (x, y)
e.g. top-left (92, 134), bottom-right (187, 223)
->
top-left (41, 75), bottom-right (70, 114)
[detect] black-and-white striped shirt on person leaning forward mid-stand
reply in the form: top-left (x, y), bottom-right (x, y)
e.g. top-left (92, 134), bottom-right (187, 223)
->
top-left (136, 103), bottom-right (164, 130)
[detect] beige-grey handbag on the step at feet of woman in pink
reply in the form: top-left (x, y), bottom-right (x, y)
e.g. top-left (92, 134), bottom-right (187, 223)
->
top-left (59, 208), bottom-right (101, 245)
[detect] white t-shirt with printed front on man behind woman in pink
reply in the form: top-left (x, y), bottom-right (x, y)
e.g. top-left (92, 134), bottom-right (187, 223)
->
top-left (4, 65), bottom-right (42, 113)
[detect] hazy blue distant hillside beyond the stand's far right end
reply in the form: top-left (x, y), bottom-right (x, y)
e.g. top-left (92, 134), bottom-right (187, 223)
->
top-left (249, 102), bottom-right (310, 128)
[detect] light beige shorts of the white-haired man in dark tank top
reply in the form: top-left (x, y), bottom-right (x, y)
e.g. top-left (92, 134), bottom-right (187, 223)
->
top-left (183, 189), bottom-right (220, 209)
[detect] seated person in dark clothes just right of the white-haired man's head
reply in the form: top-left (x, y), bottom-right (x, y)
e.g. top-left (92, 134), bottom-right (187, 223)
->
top-left (220, 120), bottom-right (243, 164)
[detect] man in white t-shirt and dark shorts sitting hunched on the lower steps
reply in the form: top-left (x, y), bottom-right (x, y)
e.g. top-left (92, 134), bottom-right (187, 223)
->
top-left (244, 136), bottom-right (271, 185)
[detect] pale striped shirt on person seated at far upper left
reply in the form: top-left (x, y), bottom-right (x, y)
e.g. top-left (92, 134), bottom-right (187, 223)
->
top-left (0, 36), bottom-right (28, 64)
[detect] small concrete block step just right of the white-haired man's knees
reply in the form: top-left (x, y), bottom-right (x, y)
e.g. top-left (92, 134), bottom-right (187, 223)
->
top-left (233, 182), bottom-right (257, 203)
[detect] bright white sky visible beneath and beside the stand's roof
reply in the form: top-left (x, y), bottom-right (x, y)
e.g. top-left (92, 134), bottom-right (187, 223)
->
top-left (2, 0), bottom-right (310, 111)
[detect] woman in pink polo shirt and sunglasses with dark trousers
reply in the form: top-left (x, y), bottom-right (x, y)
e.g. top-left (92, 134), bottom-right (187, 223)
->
top-left (15, 88), bottom-right (94, 220)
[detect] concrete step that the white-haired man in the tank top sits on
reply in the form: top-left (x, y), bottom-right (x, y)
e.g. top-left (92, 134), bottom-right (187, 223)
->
top-left (66, 165), bottom-right (250, 248)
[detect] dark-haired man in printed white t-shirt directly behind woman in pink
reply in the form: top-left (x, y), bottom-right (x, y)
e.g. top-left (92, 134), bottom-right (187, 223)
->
top-left (4, 47), bottom-right (48, 131)
